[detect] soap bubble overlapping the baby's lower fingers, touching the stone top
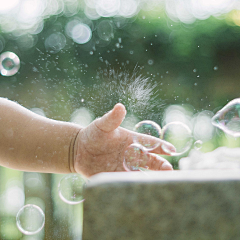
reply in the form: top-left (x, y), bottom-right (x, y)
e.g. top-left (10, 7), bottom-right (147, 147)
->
top-left (123, 143), bottom-right (148, 171)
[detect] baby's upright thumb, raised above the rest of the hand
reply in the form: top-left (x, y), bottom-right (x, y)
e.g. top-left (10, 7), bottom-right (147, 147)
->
top-left (96, 103), bottom-right (126, 132)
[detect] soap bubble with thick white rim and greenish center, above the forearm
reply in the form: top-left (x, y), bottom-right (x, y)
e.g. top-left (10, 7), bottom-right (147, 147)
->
top-left (0, 52), bottom-right (20, 76)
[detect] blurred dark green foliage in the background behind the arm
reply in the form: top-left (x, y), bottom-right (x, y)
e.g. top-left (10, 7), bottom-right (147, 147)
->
top-left (0, 5), bottom-right (240, 239)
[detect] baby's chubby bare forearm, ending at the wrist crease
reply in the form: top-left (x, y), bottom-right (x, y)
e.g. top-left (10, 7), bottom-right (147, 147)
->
top-left (0, 98), bottom-right (81, 173)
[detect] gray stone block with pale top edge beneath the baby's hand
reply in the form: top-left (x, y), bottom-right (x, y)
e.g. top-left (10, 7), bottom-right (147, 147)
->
top-left (83, 170), bottom-right (240, 240)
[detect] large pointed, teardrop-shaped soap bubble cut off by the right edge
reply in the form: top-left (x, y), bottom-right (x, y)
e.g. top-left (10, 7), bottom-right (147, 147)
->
top-left (212, 98), bottom-right (240, 137)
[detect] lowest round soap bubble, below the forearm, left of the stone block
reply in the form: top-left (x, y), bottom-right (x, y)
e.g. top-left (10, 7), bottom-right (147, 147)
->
top-left (16, 204), bottom-right (45, 235)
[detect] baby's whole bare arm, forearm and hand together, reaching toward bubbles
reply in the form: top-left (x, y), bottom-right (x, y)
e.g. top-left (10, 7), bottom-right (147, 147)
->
top-left (0, 98), bottom-right (175, 177)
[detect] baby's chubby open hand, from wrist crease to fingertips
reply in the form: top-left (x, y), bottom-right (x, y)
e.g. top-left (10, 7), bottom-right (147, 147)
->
top-left (74, 103), bottom-right (175, 177)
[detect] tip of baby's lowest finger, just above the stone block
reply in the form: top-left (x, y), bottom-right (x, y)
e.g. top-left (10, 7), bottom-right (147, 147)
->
top-left (147, 153), bottom-right (173, 171)
